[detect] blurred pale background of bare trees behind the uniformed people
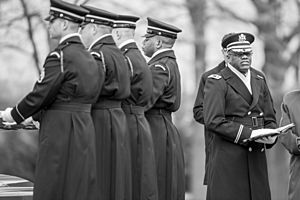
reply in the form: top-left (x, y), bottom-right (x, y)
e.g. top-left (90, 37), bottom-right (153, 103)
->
top-left (0, 0), bottom-right (300, 200)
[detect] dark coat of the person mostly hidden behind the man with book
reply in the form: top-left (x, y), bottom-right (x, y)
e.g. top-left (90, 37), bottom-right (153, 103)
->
top-left (193, 61), bottom-right (225, 185)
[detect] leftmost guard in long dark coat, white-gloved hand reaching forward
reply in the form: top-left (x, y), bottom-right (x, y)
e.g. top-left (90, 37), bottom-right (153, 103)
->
top-left (2, 0), bottom-right (101, 200)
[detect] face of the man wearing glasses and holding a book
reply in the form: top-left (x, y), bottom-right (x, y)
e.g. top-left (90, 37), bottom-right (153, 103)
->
top-left (228, 51), bottom-right (252, 74)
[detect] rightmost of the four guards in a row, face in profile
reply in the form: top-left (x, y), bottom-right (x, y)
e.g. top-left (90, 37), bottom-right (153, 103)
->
top-left (143, 17), bottom-right (185, 200)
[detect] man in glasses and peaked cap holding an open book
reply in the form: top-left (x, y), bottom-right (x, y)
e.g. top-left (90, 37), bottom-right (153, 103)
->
top-left (203, 33), bottom-right (277, 200)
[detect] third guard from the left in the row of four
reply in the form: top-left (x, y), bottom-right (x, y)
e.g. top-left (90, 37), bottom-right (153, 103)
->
top-left (113, 15), bottom-right (158, 200)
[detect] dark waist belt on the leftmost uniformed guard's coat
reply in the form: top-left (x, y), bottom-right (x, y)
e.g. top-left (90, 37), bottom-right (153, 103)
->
top-left (48, 102), bottom-right (92, 112)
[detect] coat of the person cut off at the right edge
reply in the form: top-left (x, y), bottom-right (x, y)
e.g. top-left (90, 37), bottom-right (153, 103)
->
top-left (279, 90), bottom-right (300, 200)
